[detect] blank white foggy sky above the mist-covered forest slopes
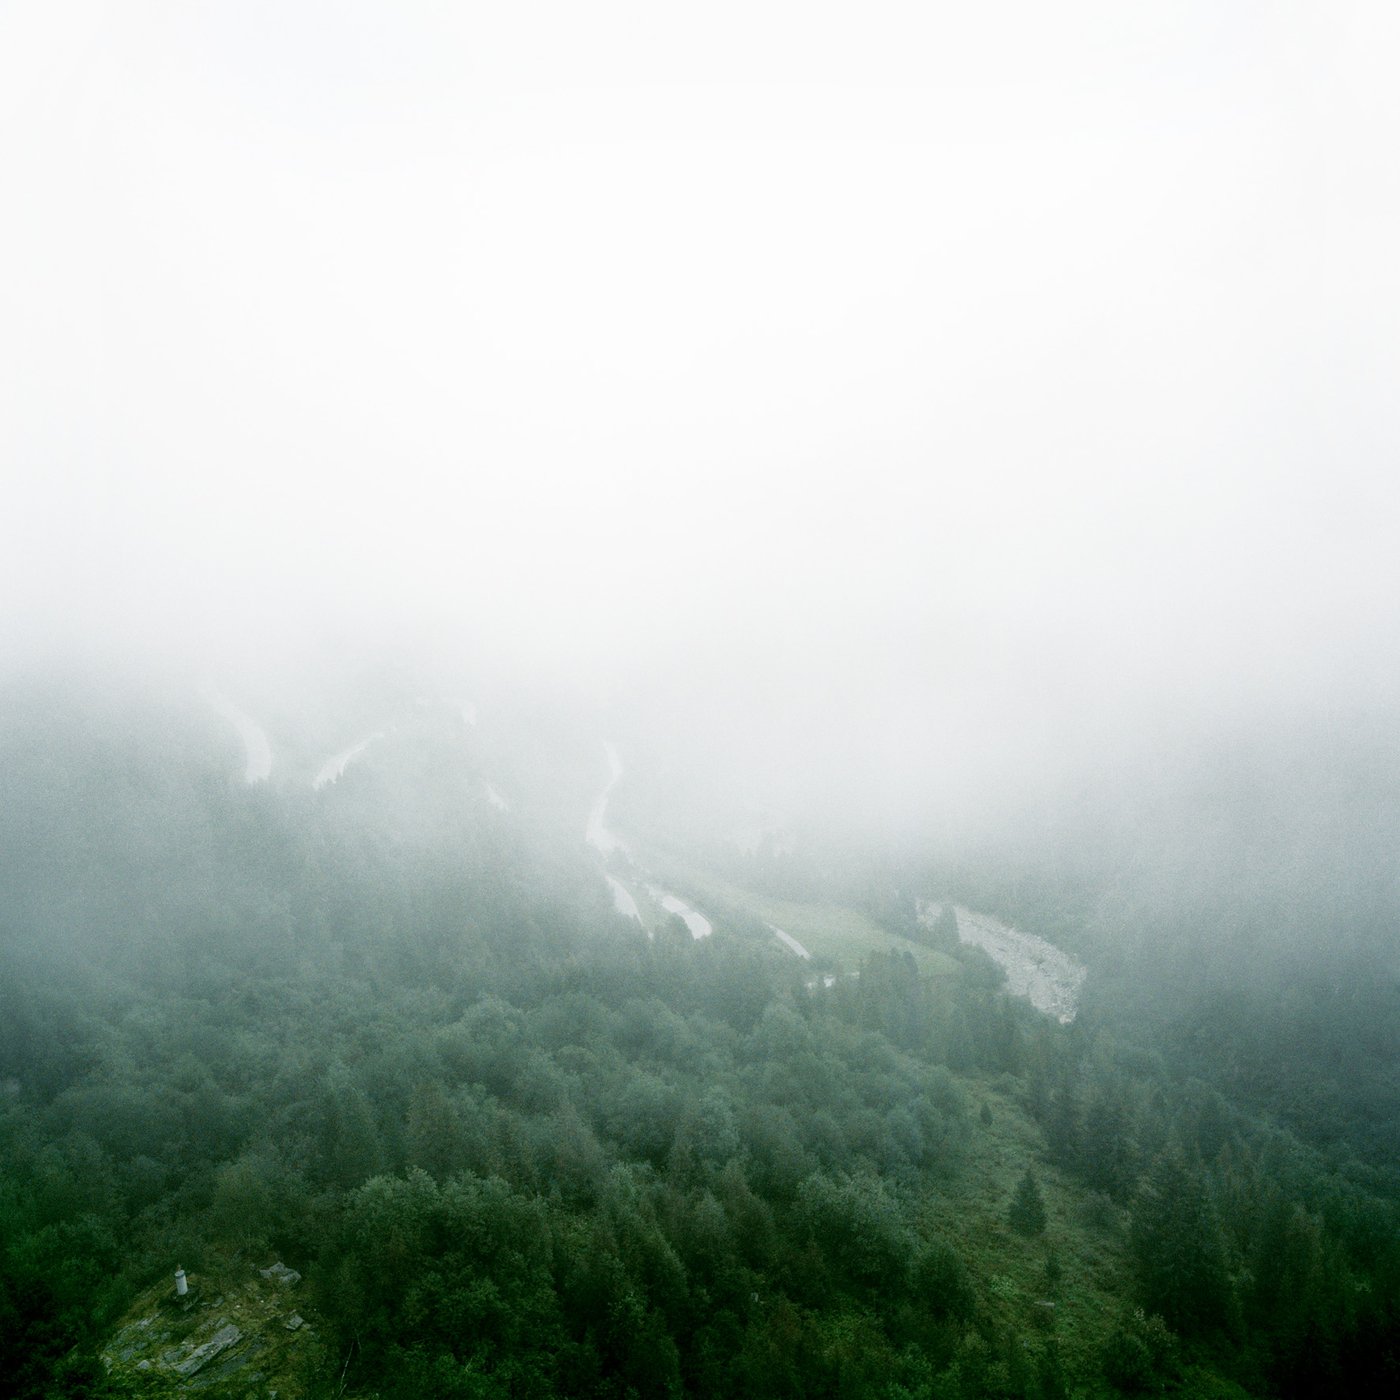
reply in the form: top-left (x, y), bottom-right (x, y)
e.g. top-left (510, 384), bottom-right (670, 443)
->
top-left (0, 0), bottom-right (1400, 722)
